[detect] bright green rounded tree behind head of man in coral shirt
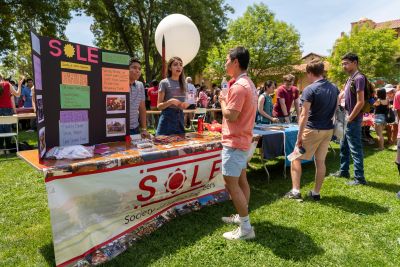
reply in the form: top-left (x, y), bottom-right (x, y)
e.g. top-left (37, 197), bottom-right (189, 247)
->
top-left (205, 4), bottom-right (301, 83)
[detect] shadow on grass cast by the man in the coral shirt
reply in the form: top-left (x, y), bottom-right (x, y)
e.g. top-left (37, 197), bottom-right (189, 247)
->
top-left (253, 222), bottom-right (325, 261)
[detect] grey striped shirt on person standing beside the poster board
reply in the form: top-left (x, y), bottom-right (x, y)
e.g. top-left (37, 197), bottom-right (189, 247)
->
top-left (129, 81), bottom-right (146, 129)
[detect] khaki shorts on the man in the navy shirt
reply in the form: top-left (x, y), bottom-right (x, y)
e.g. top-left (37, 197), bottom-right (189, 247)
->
top-left (299, 129), bottom-right (333, 160)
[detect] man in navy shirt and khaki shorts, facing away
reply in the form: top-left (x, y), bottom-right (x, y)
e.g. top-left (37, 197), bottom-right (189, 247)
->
top-left (286, 60), bottom-right (339, 200)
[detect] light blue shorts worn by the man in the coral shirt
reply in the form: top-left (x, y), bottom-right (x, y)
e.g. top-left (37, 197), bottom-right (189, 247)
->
top-left (222, 146), bottom-right (248, 178)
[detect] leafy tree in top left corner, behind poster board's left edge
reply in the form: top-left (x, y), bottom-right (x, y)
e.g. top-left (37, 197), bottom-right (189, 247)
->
top-left (0, 0), bottom-right (71, 78)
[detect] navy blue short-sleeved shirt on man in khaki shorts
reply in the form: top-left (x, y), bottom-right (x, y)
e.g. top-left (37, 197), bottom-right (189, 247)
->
top-left (300, 79), bottom-right (339, 130)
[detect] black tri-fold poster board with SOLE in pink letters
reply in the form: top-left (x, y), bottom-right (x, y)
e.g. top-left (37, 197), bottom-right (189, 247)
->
top-left (31, 32), bottom-right (129, 158)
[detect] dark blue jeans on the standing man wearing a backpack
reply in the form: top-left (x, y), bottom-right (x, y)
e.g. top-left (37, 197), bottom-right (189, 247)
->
top-left (340, 118), bottom-right (365, 182)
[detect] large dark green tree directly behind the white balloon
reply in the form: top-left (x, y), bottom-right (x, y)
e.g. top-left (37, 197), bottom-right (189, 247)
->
top-left (75, 0), bottom-right (233, 80)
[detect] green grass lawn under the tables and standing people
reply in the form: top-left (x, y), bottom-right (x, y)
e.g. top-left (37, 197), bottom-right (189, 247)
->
top-left (0, 133), bottom-right (400, 266)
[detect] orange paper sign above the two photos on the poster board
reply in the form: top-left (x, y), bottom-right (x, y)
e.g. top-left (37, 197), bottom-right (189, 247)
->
top-left (101, 68), bottom-right (129, 93)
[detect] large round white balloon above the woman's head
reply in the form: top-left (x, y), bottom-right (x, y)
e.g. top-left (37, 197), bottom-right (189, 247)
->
top-left (155, 14), bottom-right (200, 66)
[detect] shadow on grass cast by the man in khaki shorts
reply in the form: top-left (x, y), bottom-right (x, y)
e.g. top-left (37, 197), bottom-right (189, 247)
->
top-left (320, 196), bottom-right (389, 215)
